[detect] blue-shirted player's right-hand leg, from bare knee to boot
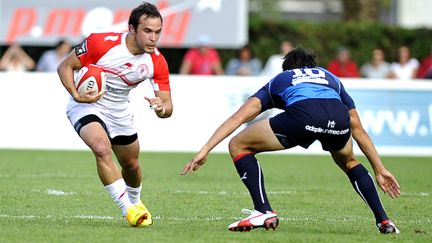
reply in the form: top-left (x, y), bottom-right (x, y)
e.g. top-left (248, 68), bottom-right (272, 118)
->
top-left (330, 138), bottom-right (399, 234)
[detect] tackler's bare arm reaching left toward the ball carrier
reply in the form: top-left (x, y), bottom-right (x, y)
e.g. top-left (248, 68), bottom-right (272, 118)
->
top-left (180, 97), bottom-right (261, 175)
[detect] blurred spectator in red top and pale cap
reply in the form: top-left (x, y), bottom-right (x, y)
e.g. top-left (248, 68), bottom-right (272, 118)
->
top-left (180, 36), bottom-right (224, 75)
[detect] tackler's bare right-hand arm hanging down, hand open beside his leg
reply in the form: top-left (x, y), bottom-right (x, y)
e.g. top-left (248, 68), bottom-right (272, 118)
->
top-left (350, 109), bottom-right (400, 198)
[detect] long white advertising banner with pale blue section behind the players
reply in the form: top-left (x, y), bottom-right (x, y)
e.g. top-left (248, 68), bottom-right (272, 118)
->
top-left (0, 72), bottom-right (432, 155)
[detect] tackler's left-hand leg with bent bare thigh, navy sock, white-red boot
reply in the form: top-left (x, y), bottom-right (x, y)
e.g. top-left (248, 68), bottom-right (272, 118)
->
top-left (228, 119), bottom-right (284, 231)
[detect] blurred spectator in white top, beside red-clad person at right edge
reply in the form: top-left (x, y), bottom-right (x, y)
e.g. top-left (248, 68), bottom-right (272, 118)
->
top-left (390, 46), bottom-right (420, 79)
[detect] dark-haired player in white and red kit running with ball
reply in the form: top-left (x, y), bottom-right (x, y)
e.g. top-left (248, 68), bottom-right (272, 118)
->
top-left (57, 2), bottom-right (173, 226)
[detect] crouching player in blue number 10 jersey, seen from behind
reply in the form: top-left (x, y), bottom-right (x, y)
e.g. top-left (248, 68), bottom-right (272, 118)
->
top-left (181, 48), bottom-right (400, 234)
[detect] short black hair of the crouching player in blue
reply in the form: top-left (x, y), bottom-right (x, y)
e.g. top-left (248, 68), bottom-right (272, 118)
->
top-left (282, 47), bottom-right (317, 71)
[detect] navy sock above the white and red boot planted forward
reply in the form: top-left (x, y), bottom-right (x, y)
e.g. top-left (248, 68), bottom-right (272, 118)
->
top-left (234, 154), bottom-right (273, 213)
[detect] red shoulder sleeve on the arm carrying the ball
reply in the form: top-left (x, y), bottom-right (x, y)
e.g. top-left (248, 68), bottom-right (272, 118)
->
top-left (78, 32), bottom-right (123, 66)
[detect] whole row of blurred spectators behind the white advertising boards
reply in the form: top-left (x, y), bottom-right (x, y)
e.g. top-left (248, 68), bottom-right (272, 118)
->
top-left (0, 36), bottom-right (432, 80)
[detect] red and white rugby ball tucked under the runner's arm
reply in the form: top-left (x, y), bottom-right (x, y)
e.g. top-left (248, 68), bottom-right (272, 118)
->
top-left (75, 64), bottom-right (106, 94)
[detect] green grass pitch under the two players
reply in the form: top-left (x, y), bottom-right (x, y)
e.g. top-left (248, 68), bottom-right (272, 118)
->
top-left (0, 150), bottom-right (432, 242)
